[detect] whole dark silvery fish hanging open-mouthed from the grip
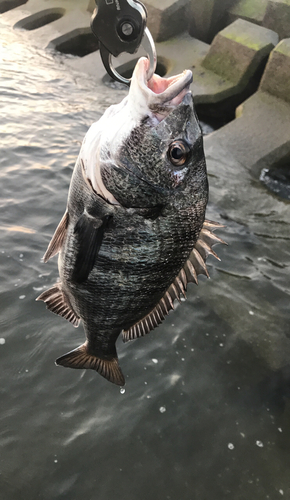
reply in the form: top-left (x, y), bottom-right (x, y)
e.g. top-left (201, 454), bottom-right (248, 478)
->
top-left (36, 57), bottom-right (225, 386)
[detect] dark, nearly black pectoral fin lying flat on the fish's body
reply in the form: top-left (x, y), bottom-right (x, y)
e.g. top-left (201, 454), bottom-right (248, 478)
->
top-left (72, 214), bottom-right (112, 283)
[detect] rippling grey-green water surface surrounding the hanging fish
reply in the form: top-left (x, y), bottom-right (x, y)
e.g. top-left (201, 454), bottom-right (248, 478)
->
top-left (0, 13), bottom-right (290, 500)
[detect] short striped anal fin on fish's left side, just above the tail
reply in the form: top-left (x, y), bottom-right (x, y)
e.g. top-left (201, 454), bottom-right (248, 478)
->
top-left (36, 283), bottom-right (80, 327)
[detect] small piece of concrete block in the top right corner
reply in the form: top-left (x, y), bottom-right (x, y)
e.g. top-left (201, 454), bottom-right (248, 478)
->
top-left (263, 0), bottom-right (290, 40)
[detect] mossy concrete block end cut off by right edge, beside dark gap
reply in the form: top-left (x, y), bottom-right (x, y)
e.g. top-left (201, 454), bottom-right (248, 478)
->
top-left (260, 38), bottom-right (290, 103)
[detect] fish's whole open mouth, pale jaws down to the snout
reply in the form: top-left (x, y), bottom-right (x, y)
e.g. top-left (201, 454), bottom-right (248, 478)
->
top-left (129, 57), bottom-right (193, 121)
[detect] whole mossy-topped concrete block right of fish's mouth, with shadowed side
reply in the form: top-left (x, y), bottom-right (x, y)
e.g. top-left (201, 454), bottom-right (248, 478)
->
top-left (192, 19), bottom-right (278, 119)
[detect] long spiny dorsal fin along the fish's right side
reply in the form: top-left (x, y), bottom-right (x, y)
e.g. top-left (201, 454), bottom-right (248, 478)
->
top-left (123, 220), bottom-right (227, 342)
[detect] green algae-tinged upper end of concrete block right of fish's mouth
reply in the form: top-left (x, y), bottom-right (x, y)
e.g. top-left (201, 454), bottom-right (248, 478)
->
top-left (202, 19), bottom-right (278, 84)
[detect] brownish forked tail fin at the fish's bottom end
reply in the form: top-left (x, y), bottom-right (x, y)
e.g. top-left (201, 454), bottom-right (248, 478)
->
top-left (55, 343), bottom-right (125, 385)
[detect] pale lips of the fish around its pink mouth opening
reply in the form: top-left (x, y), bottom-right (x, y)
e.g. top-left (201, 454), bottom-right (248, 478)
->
top-left (132, 57), bottom-right (193, 108)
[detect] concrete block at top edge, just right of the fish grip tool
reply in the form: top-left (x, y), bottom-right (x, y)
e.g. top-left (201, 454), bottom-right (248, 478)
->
top-left (143, 0), bottom-right (189, 42)
